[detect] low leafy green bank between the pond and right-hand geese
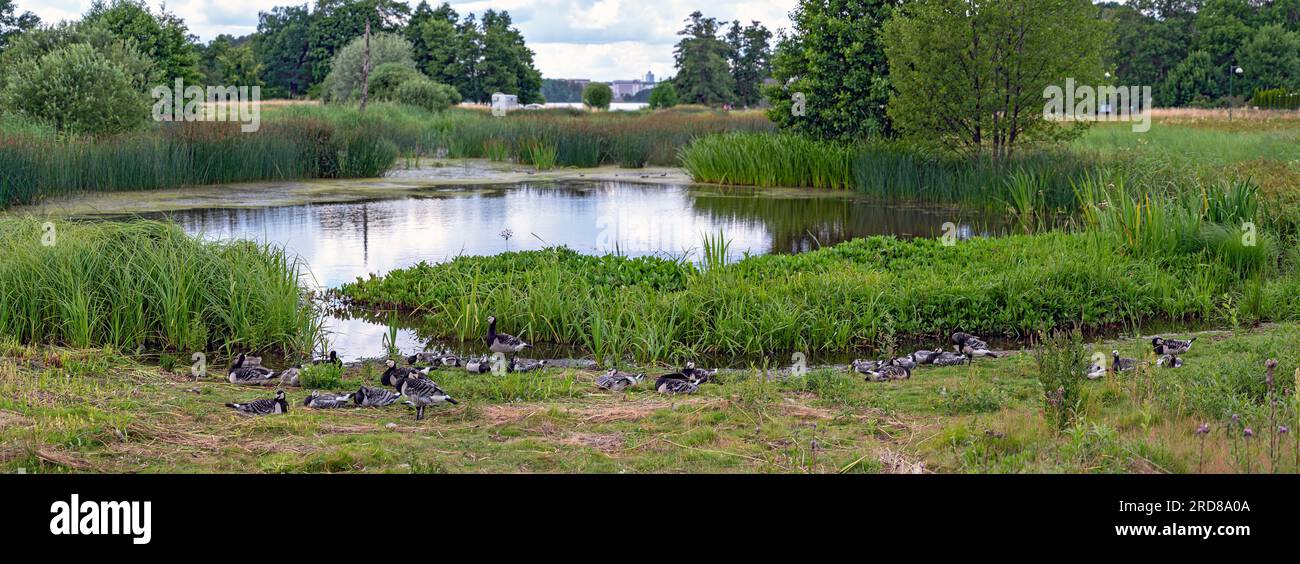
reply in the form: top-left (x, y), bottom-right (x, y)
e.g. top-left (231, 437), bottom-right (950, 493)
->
top-left (341, 204), bottom-right (1300, 360)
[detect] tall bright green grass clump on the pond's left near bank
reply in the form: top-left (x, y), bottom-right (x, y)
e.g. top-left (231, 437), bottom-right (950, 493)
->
top-left (0, 218), bottom-right (319, 353)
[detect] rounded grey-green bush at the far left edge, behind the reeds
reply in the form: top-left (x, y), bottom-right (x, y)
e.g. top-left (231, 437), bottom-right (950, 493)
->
top-left (0, 43), bottom-right (150, 135)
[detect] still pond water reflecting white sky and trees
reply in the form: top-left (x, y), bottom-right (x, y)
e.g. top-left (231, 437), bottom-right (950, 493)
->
top-left (149, 181), bottom-right (1008, 360)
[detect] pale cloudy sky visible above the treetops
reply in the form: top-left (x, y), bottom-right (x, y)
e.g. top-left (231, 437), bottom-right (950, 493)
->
top-left (17, 0), bottom-right (797, 81)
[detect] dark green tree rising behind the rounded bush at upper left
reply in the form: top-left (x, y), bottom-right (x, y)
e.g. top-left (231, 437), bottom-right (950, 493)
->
top-left (82, 0), bottom-right (203, 83)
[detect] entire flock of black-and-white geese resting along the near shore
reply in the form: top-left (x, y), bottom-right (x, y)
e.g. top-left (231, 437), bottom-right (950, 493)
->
top-left (226, 317), bottom-right (1196, 421)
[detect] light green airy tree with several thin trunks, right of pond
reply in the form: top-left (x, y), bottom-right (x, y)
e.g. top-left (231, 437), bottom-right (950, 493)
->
top-left (884, 0), bottom-right (1106, 159)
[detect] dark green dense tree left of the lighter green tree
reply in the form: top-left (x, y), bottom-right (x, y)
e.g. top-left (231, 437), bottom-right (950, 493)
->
top-left (764, 0), bottom-right (898, 139)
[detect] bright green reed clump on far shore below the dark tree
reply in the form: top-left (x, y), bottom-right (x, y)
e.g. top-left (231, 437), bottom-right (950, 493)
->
top-left (681, 133), bottom-right (855, 190)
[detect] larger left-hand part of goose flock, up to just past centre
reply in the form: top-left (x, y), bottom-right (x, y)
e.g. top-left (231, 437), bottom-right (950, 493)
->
top-left (226, 317), bottom-right (718, 421)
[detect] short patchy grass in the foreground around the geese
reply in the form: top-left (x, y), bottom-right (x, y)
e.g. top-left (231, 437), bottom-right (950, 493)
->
top-left (0, 325), bottom-right (1300, 473)
